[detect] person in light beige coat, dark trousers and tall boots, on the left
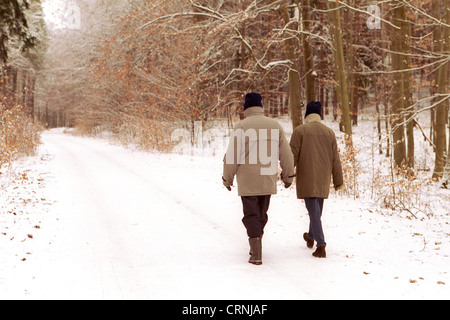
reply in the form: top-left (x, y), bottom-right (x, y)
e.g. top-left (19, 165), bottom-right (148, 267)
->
top-left (222, 92), bottom-right (294, 265)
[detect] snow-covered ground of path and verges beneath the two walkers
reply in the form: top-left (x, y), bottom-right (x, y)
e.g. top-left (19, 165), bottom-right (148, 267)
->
top-left (0, 125), bottom-right (450, 299)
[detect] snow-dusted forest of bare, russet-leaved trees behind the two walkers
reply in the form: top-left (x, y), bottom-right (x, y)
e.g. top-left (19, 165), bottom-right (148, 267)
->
top-left (0, 0), bottom-right (450, 188)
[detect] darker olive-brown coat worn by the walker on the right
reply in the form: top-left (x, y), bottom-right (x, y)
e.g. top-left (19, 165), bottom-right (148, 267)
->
top-left (290, 113), bottom-right (344, 199)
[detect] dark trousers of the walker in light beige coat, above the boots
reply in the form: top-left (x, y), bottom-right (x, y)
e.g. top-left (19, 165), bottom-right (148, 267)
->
top-left (241, 194), bottom-right (270, 238)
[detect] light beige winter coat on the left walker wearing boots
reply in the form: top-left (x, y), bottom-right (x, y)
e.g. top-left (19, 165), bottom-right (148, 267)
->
top-left (222, 107), bottom-right (294, 196)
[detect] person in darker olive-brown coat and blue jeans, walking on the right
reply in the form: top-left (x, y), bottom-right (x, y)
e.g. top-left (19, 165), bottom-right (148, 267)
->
top-left (290, 101), bottom-right (344, 258)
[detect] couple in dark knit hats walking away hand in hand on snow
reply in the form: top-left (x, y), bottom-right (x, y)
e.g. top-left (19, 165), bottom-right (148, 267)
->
top-left (222, 92), bottom-right (343, 265)
